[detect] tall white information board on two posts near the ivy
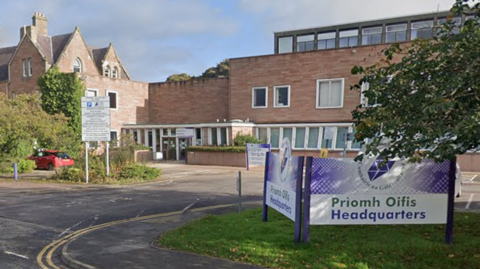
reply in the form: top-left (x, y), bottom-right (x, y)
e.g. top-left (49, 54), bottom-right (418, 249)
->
top-left (82, 96), bottom-right (110, 142)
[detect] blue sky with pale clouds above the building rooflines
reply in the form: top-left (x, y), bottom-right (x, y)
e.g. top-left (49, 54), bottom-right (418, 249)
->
top-left (0, 0), bottom-right (454, 82)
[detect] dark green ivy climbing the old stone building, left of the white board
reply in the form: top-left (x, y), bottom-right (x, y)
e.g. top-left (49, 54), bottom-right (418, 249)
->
top-left (37, 67), bottom-right (85, 139)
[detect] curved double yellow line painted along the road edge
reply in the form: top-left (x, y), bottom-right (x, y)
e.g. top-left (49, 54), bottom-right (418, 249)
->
top-left (37, 204), bottom-right (234, 269)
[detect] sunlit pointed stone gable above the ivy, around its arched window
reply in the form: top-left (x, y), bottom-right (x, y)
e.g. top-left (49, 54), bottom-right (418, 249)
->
top-left (55, 30), bottom-right (100, 76)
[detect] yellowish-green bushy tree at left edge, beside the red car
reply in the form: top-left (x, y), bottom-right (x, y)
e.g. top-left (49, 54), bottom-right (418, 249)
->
top-left (0, 94), bottom-right (74, 165)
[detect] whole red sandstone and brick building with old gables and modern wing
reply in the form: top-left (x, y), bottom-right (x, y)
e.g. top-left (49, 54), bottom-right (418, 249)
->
top-left (0, 13), bottom-right (480, 170)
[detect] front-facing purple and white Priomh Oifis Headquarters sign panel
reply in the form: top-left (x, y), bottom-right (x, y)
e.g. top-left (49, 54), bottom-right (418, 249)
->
top-left (310, 157), bottom-right (450, 225)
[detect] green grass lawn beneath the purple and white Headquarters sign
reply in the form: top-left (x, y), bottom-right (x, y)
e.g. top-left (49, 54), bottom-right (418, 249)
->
top-left (157, 209), bottom-right (480, 269)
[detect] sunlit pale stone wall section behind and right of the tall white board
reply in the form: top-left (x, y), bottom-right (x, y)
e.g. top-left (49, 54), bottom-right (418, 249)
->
top-left (85, 76), bottom-right (149, 132)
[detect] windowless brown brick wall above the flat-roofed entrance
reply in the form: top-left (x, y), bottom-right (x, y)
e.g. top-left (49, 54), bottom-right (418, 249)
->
top-left (149, 78), bottom-right (229, 124)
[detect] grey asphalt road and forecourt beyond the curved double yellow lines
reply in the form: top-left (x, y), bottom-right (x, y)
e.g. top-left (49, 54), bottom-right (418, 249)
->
top-left (0, 164), bottom-right (480, 269)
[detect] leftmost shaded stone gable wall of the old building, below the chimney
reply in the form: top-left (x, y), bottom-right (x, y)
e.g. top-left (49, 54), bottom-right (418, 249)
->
top-left (9, 37), bottom-right (46, 97)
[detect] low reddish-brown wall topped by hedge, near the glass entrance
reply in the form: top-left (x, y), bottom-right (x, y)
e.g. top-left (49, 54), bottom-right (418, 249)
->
top-left (187, 151), bottom-right (247, 167)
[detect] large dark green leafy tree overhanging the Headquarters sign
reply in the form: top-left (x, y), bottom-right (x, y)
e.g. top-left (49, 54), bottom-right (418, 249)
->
top-left (351, 0), bottom-right (480, 161)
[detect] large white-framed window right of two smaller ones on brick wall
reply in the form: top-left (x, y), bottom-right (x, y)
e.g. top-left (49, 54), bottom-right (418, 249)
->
top-left (317, 78), bottom-right (344, 108)
